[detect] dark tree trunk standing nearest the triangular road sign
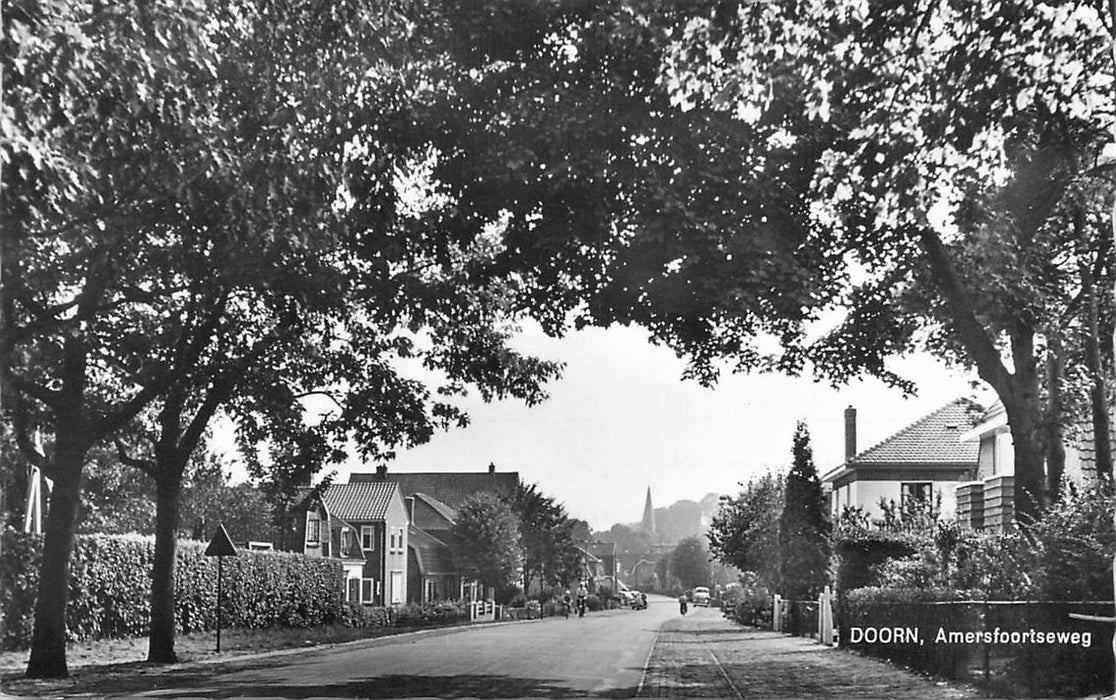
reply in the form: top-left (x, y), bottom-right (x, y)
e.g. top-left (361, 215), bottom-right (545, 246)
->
top-left (147, 468), bottom-right (182, 663)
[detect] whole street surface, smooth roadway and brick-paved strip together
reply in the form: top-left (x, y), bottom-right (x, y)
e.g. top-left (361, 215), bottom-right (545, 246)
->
top-left (6, 597), bottom-right (975, 699)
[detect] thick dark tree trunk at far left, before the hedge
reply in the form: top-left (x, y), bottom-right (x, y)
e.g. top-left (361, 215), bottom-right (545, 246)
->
top-left (27, 433), bottom-right (87, 678)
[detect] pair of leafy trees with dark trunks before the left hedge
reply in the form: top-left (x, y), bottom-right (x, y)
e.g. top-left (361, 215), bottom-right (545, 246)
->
top-left (2, 0), bottom-right (566, 675)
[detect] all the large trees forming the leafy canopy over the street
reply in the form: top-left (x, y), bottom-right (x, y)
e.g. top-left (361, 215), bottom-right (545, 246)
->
top-left (0, 0), bottom-right (1116, 675)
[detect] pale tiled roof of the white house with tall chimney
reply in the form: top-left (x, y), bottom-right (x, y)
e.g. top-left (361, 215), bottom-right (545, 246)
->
top-left (844, 399), bottom-right (983, 468)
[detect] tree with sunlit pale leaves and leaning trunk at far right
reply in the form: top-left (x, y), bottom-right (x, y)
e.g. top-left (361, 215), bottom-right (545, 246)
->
top-left (665, 0), bottom-right (1114, 518)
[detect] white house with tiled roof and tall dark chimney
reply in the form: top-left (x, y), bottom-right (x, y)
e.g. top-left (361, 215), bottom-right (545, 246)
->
top-left (821, 399), bottom-right (982, 518)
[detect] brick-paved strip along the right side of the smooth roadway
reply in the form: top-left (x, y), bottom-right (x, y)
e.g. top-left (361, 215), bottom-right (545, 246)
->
top-left (639, 611), bottom-right (981, 700)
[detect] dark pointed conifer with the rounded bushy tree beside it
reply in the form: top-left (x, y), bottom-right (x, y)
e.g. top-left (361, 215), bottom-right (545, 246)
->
top-left (709, 422), bottom-right (830, 600)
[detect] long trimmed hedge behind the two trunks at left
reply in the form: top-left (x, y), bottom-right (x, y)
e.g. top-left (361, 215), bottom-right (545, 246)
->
top-left (0, 529), bottom-right (344, 649)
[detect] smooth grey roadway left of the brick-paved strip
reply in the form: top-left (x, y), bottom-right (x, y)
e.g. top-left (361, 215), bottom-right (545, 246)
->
top-left (176, 600), bottom-right (677, 698)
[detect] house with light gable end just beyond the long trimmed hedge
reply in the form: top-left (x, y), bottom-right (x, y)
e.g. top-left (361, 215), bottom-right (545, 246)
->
top-left (300, 482), bottom-right (408, 605)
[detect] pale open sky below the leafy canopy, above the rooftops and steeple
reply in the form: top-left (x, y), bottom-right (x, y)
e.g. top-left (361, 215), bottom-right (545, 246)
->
top-left (261, 327), bottom-right (988, 530)
